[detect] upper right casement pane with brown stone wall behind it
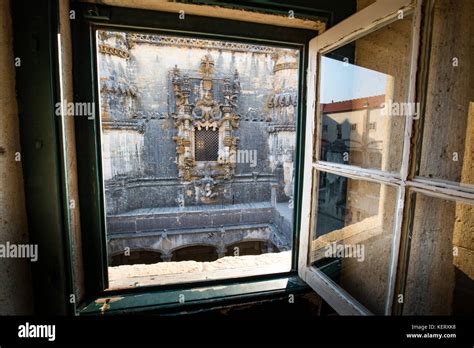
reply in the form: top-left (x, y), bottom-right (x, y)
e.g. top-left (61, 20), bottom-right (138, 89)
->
top-left (419, 0), bottom-right (474, 189)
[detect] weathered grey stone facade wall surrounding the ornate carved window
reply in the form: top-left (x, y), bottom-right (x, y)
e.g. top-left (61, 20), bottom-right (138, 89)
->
top-left (98, 31), bottom-right (298, 215)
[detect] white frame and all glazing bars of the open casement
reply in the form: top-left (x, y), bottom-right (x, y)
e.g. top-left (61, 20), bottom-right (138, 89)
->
top-left (298, 0), bottom-right (474, 315)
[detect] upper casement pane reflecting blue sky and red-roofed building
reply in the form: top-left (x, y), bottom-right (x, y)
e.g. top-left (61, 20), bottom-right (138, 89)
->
top-left (319, 16), bottom-right (416, 172)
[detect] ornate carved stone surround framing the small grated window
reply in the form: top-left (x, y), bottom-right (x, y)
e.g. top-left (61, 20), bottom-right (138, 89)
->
top-left (170, 55), bottom-right (241, 193)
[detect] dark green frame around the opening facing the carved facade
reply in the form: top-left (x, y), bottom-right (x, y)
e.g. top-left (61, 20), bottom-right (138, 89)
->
top-left (72, 3), bottom-right (317, 312)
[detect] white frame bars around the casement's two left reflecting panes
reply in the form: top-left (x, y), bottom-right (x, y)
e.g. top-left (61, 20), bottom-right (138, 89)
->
top-left (298, 0), bottom-right (421, 315)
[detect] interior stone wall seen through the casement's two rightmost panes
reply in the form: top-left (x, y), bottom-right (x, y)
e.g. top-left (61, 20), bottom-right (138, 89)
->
top-left (403, 0), bottom-right (474, 315)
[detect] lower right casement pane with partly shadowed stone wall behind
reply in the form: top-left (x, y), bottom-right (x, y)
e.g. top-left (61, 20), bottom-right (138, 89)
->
top-left (403, 193), bottom-right (474, 315)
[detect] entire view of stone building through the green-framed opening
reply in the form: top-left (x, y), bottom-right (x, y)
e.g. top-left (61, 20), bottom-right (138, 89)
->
top-left (97, 30), bottom-right (299, 289)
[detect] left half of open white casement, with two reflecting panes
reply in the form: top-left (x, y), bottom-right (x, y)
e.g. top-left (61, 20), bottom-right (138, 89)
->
top-left (299, 0), bottom-right (419, 314)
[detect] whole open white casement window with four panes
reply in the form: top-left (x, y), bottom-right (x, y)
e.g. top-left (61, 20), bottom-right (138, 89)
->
top-left (298, 0), bottom-right (474, 315)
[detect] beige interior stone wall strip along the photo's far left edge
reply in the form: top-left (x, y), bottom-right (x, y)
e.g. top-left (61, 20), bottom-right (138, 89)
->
top-left (0, 0), bottom-right (33, 315)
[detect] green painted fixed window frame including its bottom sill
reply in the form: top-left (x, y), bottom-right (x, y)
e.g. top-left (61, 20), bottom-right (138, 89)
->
top-left (72, 3), bottom-right (324, 315)
